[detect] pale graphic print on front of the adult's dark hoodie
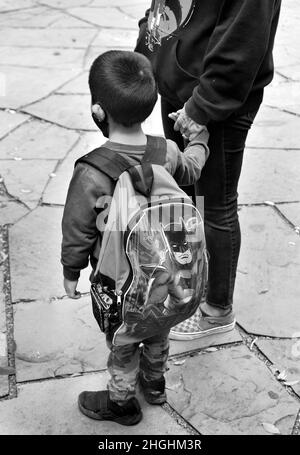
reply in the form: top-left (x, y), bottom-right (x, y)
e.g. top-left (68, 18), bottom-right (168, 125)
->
top-left (146, 0), bottom-right (195, 51)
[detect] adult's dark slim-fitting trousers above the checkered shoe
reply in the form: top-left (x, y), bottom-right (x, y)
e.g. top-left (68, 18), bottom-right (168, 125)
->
top-left (161, 99), bottom-right (257, 309)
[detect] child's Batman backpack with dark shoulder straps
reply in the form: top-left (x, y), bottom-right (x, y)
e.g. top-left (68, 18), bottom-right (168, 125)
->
top-left (76, 136), bottom-right (208, 345)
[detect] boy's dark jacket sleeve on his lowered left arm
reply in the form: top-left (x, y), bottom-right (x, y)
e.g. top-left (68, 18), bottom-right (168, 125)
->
top-left (61, 164), bottom-right (111, 281)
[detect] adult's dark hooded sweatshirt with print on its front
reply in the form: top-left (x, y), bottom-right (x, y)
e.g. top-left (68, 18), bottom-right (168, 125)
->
top-left (135, 0), bottom-right (281, 124)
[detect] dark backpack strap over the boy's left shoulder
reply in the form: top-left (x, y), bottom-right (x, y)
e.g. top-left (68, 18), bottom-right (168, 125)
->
top-left (75, 147), bottom-right (132, 181)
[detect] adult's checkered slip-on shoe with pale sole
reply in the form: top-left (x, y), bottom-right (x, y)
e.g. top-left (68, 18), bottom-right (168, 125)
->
top-left (169, 307), bottom-right (235, 341)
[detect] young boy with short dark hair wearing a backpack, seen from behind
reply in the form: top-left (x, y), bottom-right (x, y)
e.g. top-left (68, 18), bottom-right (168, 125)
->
top-left (62, 51), bottom-right (209, 425)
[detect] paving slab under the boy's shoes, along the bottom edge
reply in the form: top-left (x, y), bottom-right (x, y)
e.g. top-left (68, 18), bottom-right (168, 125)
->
top-left (0, 373), bottom-right (190, 436)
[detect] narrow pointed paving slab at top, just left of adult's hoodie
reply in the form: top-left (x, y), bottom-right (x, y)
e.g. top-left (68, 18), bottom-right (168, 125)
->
top-left (68, 5), bottom-right (137, 30)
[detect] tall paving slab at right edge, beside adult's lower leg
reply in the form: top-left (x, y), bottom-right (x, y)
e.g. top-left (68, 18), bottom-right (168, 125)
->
top-left (234, 207), bottom-right (300, 337)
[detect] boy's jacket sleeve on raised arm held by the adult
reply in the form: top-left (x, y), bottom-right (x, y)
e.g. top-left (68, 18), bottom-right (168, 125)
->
top-left (165, 128), bottom-right (209, 185)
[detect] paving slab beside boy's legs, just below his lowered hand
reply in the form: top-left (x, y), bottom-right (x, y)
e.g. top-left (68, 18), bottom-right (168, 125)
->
top-left (14, 296), bottom-right (108, 382)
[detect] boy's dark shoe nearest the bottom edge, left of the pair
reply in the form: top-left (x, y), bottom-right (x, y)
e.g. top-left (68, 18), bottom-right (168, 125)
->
top-left (78, 390), bottom-right (143, 425)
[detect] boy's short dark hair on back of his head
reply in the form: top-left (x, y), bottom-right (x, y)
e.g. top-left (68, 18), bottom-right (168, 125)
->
top-left (89, 50), bottom-right (157, 127)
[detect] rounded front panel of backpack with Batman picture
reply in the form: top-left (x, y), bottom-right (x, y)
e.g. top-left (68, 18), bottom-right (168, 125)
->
top-left (123, 203), bottom-right (206, 330)
